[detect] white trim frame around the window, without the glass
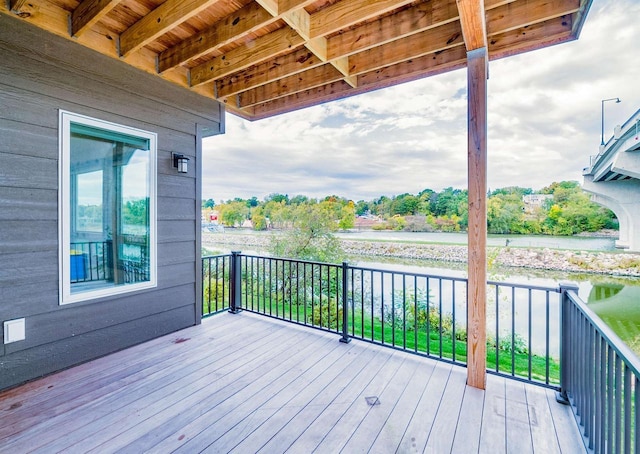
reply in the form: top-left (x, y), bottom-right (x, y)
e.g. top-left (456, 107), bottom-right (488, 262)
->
top-left (58, 110), bottom-right (157, 305)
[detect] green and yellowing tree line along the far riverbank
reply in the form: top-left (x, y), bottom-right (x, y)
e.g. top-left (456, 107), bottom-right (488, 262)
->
top-left (202, 181), bottom-right (617, 235)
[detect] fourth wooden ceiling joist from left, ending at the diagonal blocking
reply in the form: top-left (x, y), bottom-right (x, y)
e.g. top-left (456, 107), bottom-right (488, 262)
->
top-left (191, 27), bottom-right (304, 86)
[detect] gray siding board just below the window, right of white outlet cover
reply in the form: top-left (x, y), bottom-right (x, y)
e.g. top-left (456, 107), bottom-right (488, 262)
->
top-left (6, 285), bottom-right (195, 354)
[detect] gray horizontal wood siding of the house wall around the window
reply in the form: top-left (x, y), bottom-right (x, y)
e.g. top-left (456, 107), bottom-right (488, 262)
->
top-left (0, 16), bottom-right (224, 389)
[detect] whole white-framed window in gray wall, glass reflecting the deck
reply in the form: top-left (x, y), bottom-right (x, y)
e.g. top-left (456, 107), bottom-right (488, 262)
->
top-left (60, 111), bottom-right (156, 304)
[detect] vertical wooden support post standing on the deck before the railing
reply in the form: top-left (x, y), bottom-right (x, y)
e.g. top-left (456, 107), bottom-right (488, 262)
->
top-left (467, 47), bottom-right (488, 389)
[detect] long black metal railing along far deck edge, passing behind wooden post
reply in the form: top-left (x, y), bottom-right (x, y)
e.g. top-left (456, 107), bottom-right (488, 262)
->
top-left (203, 252), bottom-right (560, 389)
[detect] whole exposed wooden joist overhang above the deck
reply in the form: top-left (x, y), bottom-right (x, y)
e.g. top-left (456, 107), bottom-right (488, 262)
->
top-left (0, 0), bottom-right (591, 120)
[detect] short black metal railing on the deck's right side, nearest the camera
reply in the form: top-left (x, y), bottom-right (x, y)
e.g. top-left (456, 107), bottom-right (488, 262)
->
top-left (559, 286), bottom-right (640, 453)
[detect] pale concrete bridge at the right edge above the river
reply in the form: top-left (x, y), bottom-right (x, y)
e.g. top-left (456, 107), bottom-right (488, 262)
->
top-left (582, 110), bottom-right (640, 252)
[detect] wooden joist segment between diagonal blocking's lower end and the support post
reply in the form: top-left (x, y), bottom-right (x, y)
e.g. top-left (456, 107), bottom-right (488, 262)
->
top-left (349, 22), bottom-right (464, 74)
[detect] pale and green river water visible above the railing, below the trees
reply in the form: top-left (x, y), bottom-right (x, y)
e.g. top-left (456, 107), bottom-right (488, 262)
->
top-left (202, 229), bottom-right (640, 356)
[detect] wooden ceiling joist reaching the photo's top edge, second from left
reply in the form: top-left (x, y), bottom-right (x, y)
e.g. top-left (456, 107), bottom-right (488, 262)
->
top-left (120, 0), bottom-right (220, 57)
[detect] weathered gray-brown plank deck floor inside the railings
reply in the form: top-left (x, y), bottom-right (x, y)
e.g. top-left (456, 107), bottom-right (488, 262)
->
top-left (0, 313), bottom-right (585, 454)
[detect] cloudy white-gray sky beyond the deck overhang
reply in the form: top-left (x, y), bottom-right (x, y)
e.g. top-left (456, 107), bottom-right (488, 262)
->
top-left (202, 0), bottom-right (640, 203)
